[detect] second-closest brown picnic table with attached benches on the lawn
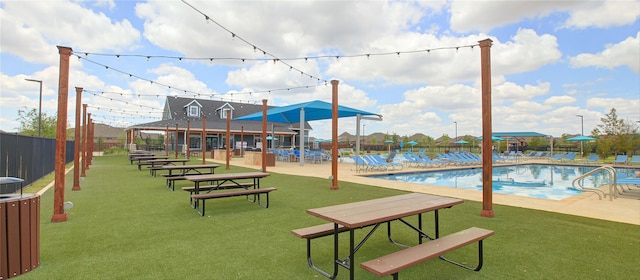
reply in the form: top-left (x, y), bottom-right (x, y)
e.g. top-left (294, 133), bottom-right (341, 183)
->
top-left (183, 172), bottom-right (275, 216)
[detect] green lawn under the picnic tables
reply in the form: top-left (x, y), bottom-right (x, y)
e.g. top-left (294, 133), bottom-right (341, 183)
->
top-left (18, 156), bottom-right (640, 279)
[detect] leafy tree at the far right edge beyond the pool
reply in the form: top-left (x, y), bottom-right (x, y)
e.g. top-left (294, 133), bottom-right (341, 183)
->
top-left (591, 108), bottom-right (640, 158)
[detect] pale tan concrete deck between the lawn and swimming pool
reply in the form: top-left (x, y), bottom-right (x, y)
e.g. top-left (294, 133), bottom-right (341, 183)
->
top-left (207, 157), bottom-right (640, 225)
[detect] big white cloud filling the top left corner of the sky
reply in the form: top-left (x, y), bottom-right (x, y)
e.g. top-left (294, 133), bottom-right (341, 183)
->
top-left (0, 1), bottom-right (140, 64)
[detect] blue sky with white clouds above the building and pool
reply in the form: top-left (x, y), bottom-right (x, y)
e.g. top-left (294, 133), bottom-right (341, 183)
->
top-left (0, 0), bottom-right (640, 138)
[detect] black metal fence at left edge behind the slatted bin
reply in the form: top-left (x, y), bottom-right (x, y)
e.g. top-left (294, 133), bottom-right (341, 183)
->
top-left (0, 133), bottom-right (74, 191)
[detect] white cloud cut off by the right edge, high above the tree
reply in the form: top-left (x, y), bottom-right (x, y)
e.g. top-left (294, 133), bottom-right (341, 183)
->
top-left (570, 32), bottom-right (640, 73)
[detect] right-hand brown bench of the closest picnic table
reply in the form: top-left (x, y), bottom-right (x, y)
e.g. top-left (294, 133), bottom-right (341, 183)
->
top-left (360, 227), bottom-right (493, 280)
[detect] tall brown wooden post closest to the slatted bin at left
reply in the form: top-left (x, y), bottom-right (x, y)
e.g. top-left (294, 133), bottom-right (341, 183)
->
top-left (51, 46), bottom-right (73, 223)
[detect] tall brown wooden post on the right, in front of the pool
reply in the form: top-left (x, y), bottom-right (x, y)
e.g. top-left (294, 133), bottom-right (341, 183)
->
top-left (479, 39), bottom-right (494, 218)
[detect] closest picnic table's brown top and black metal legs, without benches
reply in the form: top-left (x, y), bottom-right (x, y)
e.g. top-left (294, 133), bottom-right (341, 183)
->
top-left (307, 193), bottom-right (463, 279)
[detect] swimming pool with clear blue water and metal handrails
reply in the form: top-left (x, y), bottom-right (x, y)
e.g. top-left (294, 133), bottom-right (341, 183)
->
top-left (369, 164), bottom-right (631, 200)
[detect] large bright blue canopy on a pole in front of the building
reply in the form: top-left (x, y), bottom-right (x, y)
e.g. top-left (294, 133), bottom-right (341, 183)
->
top-left (236, 100), bottom-right (380, 165)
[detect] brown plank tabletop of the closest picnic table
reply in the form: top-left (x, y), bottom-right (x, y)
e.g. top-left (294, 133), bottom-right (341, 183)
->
top-left (307, 193), bottom-right (463, 228)
